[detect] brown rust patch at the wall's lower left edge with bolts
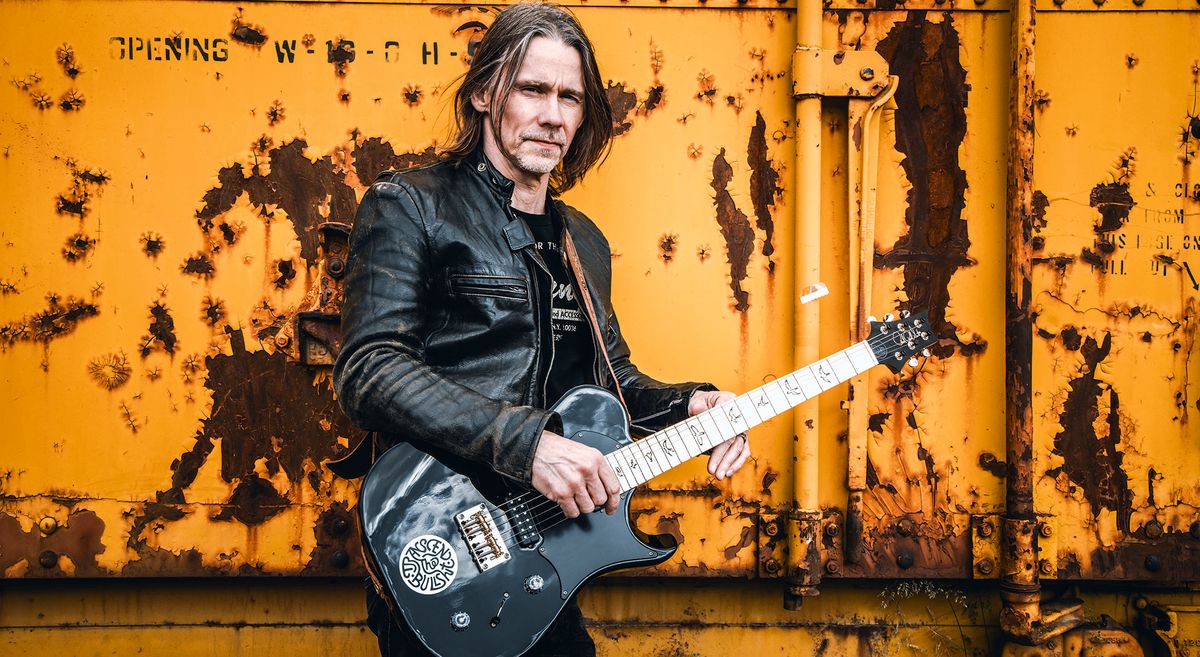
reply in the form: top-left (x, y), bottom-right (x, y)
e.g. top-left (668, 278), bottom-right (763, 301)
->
top-left (0, 511), bottom-right (107, 577)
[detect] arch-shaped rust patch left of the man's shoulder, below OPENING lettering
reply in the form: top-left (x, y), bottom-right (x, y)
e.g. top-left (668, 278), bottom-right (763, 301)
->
top-left (196, 139), bottom-right (358, 263)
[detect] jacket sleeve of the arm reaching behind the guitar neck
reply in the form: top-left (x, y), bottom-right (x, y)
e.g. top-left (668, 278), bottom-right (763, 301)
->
top-left (605, 313), bottom-right (716, 430)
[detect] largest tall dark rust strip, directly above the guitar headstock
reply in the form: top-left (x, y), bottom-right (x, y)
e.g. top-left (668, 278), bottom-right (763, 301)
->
top-left (875, 11), bottom-right (986, 357)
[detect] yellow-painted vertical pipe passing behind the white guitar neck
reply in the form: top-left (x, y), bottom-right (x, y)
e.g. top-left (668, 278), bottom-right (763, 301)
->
top-left (784, 0), bottom-right (822, 609)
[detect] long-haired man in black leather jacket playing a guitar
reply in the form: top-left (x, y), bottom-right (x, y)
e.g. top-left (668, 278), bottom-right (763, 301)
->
top-left (334, 4), bottom-right (750, 656)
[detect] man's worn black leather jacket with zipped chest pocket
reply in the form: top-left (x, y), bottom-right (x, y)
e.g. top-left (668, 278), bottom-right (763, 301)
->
top-left (334, 152), bottom-right (710, 483)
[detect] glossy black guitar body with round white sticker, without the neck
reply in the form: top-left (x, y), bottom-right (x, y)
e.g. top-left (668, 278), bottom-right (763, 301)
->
top-left (359, 386), bottom-right (676, 657)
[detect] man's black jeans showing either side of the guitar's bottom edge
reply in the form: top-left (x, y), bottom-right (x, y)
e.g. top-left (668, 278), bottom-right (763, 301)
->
top-left (366, 578), bottom-right (596, 657)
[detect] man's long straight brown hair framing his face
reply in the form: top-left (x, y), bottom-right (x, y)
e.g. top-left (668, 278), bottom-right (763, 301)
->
top-left (443, 2), bottom-right (612, 193)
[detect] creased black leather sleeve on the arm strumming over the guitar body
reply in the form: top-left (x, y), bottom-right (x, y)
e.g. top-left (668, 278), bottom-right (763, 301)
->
top-left (334, 182), bottom-right (557, 483)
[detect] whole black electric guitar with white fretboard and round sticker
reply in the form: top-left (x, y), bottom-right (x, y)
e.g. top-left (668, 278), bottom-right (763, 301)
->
top-left (359, 313), bottom-right (935, 657)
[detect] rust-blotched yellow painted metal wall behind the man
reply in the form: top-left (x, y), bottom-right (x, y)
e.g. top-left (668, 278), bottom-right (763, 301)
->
top-left (0, 0), bottom-right (1200, 655)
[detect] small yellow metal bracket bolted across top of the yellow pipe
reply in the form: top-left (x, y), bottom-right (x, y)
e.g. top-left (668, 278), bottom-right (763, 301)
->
top-left (792, 47), bottom-right (889, 98)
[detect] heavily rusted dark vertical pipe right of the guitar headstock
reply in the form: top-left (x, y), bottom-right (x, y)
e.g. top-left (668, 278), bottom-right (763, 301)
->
top-left (1000, 0), bottom-right (1042, 638)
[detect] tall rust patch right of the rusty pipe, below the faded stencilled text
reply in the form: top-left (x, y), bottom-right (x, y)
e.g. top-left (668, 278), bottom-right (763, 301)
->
top-left (1046, 333), bottom-right (1133, 534)
